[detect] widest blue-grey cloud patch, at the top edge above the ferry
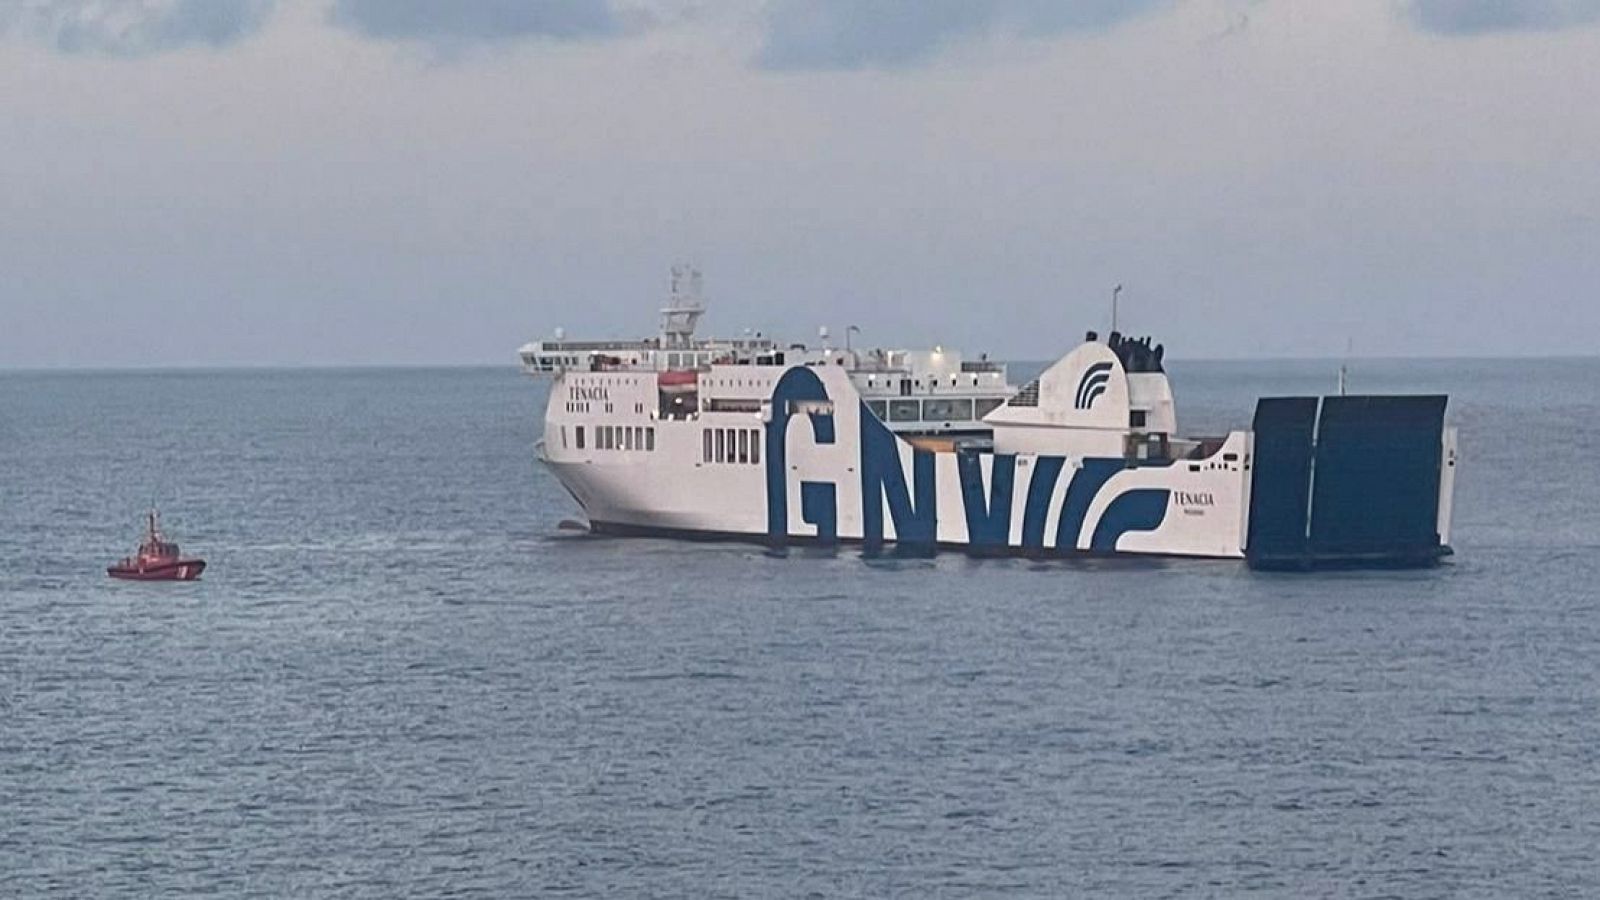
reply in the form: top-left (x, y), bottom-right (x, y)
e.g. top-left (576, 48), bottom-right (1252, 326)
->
top-left (757, 0), bottom-right (1170, 69)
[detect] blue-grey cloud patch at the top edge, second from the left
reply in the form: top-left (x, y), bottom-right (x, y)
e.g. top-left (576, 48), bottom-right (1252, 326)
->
top-left (333, 0), bottom-right (621, 46)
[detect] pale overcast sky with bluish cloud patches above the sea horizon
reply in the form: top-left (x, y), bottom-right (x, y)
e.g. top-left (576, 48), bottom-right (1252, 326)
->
top-left (0, 0), bottom-right (1600, 367)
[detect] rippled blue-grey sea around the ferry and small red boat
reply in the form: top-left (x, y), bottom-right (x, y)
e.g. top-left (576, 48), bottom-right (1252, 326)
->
top-left (0, 359), bottom-right (1600, 898)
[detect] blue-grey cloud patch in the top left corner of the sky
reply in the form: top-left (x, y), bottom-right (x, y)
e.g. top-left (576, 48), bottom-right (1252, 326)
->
top-left (0, 0), bottom-right (275, 56)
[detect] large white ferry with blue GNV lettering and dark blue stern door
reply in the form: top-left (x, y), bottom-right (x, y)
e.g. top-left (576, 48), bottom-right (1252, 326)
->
top-left (520, 269), bottom-right (1456, 570)
